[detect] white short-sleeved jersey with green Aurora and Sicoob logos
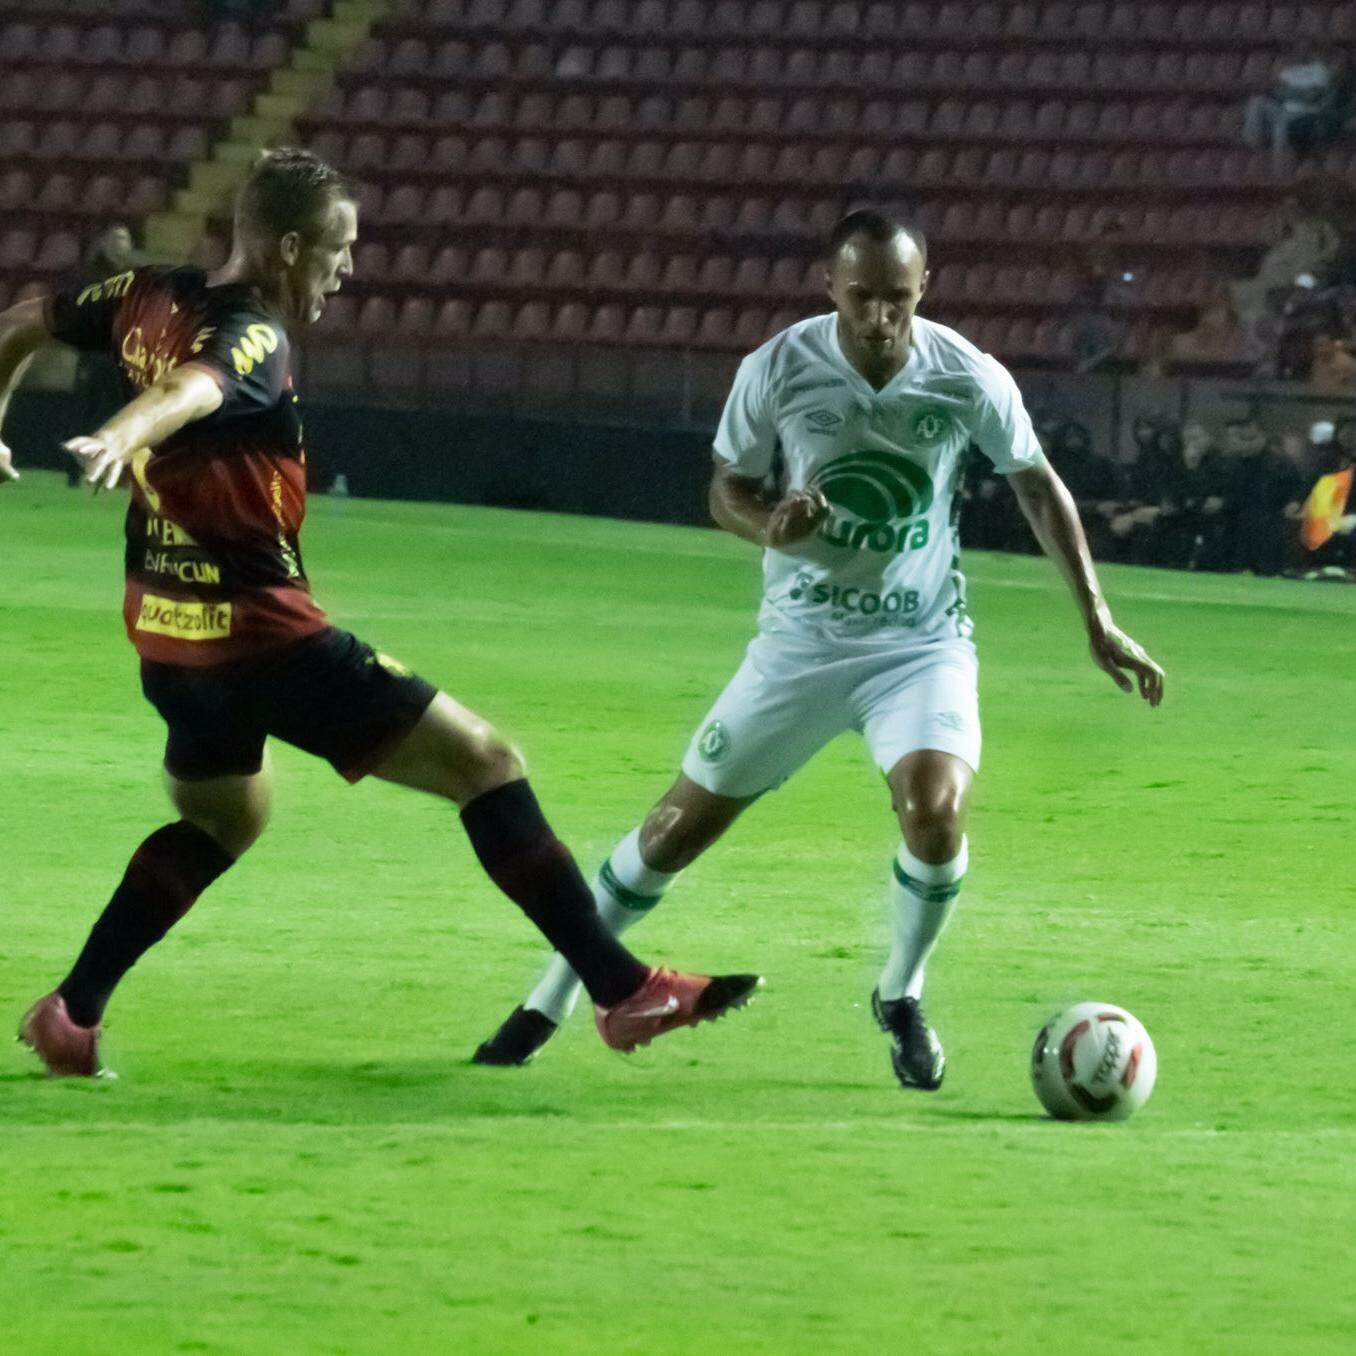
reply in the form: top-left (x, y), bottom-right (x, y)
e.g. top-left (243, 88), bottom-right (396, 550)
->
top-left (715, 313), bottom-right (1044, 644)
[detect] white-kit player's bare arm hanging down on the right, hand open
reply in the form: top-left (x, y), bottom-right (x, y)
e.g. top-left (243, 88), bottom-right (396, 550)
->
top-left (1008, 462), bottom-right (1163, 706)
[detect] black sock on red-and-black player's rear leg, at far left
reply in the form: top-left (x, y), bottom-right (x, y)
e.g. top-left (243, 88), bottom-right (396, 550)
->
top-left (57, 819), bottom-right (235, 1026)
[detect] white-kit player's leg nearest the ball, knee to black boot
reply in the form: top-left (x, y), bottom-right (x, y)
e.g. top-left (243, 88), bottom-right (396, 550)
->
top-left (872, 749), bottom-right (975, 1090)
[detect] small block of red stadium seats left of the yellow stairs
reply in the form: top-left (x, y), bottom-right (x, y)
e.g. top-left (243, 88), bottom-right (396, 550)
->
top-left (0, 0), bottom-right (320, 310)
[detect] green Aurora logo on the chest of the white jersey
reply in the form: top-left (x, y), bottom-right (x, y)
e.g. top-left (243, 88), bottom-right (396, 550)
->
top-left (811, 450), bottom-right (933, 555)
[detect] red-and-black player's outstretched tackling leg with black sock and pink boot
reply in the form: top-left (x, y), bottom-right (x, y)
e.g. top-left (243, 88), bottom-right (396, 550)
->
top-left (374, 693), bottom-right (758, 1050)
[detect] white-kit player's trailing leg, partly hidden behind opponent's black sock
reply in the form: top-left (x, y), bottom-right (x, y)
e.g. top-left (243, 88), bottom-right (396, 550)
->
top-left (472, 774), bottom-right (754, 1066)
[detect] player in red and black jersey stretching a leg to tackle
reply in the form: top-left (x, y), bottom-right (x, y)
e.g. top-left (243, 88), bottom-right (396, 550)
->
top-left (0, 149), bottom-right (758, 1075)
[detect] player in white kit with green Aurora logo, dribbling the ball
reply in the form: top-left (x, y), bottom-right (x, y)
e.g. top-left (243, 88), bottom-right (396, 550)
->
top-left (475, 212), bottom-right (1163, 1089)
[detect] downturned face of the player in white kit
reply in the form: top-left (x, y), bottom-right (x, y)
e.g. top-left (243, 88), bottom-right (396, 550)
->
top-left (829, 233), bottom-right (928, 367)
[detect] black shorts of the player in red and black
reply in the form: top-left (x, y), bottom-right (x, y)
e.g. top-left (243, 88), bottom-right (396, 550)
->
top-left (141, 626), bottom-right (438, 781)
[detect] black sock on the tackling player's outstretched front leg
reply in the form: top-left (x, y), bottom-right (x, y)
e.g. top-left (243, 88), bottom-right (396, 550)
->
top-left (461, 781), bottom-right (648, 1008)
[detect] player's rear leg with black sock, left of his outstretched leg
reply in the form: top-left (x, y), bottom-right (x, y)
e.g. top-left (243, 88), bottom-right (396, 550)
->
top-left (19, 770), bottom-right (270, 1077)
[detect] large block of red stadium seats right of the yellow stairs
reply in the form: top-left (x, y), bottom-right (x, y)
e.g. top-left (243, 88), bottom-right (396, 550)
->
top-left (275, 0), bottom-right (1356, 385)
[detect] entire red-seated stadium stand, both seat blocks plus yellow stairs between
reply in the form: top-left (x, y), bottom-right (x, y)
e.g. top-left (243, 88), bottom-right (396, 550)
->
top-left (0, 0), bottom-right (1356, 391)
